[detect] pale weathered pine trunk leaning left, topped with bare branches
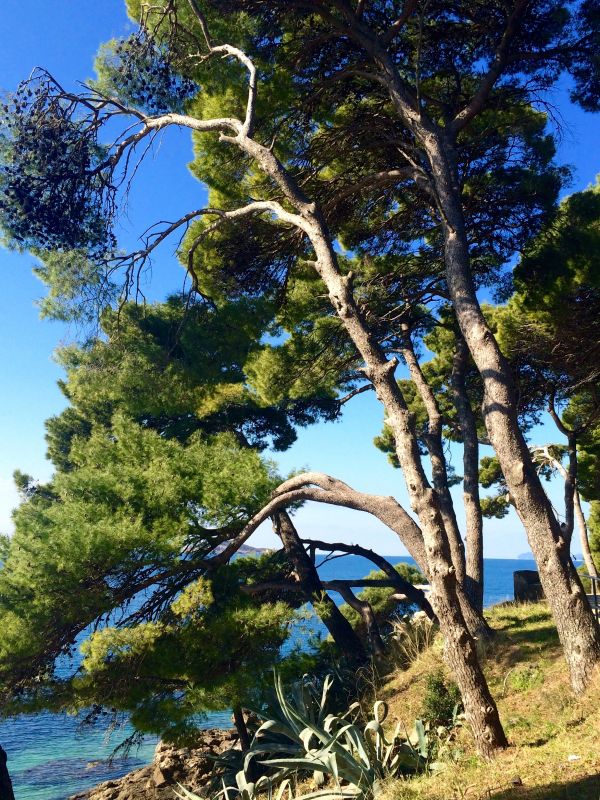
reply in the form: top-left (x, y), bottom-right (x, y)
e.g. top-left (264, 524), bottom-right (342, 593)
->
top-left (220, 108), bottom-right (507, 757)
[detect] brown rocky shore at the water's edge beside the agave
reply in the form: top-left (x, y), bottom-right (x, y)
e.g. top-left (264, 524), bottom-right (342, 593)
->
top-left (69, 728), bottom-right (239, 800)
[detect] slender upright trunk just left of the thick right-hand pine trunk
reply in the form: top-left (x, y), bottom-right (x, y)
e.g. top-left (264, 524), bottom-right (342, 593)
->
top-left (452, 333), bottom-right (483, 611)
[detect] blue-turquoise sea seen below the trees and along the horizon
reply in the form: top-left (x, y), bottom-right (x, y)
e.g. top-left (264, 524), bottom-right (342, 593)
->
top-left (0, 554), bottom-right (536, 800)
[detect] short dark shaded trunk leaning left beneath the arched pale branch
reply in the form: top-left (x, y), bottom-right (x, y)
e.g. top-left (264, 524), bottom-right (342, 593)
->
top-left (273, 511), bottom-right (367, 661)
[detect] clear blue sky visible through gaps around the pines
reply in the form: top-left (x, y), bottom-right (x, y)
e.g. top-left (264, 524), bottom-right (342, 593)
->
top-left (0, 0), bottom-right (600, 558)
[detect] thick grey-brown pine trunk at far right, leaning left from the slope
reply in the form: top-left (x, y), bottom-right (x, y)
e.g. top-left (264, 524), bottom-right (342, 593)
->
top-left (424, 134), bottom-right (600, 692)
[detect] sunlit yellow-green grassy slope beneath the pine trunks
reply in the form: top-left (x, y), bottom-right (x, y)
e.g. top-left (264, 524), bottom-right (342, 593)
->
top-left (384, 603), bottom-right (600, 800)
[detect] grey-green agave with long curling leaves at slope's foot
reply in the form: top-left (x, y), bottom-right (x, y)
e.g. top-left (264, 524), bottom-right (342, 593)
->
top-left (179, 673), bottom-right (432, 800)
